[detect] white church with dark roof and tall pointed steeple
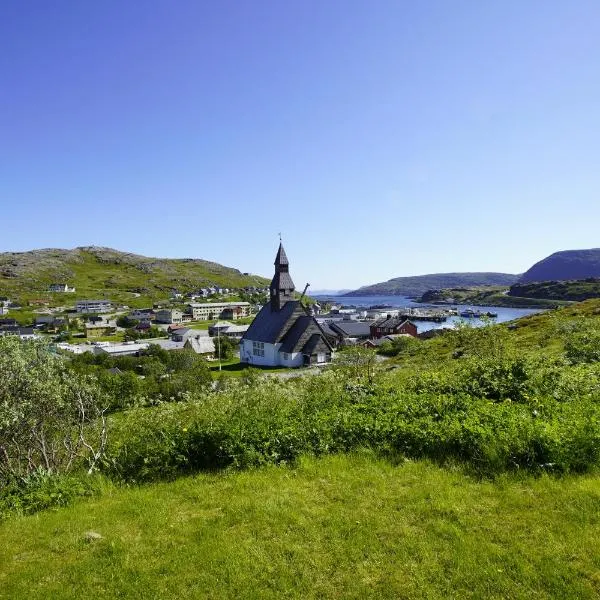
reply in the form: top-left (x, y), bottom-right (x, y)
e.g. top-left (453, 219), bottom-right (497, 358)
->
top-left (240, 244), bottom-right (333, 367)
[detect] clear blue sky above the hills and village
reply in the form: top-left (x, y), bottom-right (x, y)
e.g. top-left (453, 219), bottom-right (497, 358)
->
top-left (0, 0), bottom-right (600, 289)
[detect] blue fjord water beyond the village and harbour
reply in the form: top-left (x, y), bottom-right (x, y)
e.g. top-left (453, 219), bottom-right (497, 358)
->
top-left (314, 296), bottom-right (541, 333)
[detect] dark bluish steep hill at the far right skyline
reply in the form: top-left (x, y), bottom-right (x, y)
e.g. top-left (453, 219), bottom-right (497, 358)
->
top-left (519, 248), bottom-right (600, 283)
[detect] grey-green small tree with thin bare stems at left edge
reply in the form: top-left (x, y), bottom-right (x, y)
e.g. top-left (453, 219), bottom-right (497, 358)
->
top-left (0, 336), bottom-right (106, 481)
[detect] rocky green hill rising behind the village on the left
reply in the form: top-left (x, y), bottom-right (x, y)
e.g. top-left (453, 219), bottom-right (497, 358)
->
top-left (0, 246), bottom-right (268, 306)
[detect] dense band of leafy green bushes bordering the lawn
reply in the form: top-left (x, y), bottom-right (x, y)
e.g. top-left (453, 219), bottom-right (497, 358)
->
top-left (104, 364), bottom-right (600, 481)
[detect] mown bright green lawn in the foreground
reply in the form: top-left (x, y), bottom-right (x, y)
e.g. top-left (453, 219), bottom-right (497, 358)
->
top-left (0, 452), bottom-right (600, 599)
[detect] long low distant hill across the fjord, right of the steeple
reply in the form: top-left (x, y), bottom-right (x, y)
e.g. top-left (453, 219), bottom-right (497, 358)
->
top-left (344, 273), bottom-right (519, 297)
